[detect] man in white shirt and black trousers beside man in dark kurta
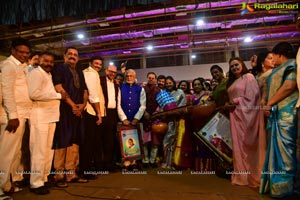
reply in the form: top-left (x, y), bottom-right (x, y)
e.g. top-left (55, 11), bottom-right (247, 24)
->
top-left (79, 57), bottom-right (106, 179)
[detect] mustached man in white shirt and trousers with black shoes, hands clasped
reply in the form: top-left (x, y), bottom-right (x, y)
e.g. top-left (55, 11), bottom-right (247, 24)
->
top-left (27, 52), bottom-right (64, 194)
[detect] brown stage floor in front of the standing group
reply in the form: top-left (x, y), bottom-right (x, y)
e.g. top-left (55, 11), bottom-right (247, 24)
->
top-left (12, 169), bottom-right (288, 200)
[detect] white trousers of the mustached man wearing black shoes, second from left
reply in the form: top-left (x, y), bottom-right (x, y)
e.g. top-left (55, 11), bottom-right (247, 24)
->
top-left (29, 122), bottom-right (56, 188)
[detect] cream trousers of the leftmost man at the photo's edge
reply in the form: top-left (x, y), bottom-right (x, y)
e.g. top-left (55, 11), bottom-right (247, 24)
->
top-left (0, 118), bottom-right (26, 191)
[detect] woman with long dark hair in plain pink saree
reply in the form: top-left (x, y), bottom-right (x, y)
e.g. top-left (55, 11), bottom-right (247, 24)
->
top-left (226, 57), bottom-right (266, 188)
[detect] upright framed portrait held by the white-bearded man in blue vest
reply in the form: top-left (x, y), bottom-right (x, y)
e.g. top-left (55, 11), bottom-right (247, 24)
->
top-left (118, 124), bottom-right (143, 160)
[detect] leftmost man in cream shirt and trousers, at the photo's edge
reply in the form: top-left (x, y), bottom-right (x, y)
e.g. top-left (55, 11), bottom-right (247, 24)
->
top-left (0, 38), bottom-right (32, 192)
